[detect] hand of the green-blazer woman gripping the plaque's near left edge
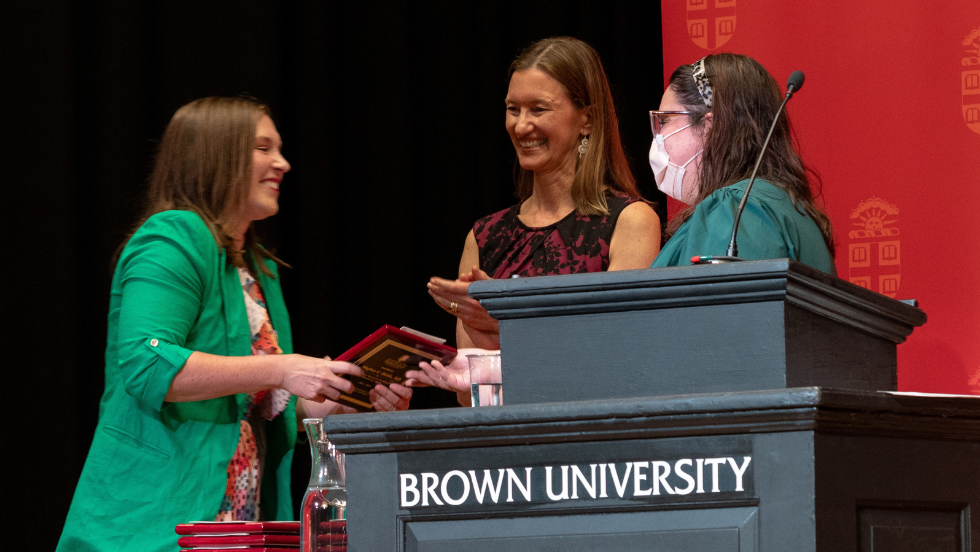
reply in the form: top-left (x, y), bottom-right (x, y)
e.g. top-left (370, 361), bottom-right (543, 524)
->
top-left (277, 355), bottom-right (364, 402)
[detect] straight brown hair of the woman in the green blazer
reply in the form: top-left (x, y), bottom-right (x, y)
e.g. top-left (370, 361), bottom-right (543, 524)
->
top-left (120, 97), bottom-right (284, 276)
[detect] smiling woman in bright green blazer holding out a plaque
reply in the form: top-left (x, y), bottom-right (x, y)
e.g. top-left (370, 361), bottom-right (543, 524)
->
top-left (58, 98), bottom-right (411, 552)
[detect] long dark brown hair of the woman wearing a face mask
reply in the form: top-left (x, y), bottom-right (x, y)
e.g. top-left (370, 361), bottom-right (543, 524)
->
top-left (667, 54), bottom-right (834, 256)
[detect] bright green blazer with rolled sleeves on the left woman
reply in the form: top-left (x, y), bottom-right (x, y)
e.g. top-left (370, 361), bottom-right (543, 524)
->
top-left (58, 211), bottom-right (296, 552)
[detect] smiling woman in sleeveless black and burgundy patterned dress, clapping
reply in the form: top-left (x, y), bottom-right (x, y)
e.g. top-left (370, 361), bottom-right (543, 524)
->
top-left (428, 37), bottom-right (660, 354)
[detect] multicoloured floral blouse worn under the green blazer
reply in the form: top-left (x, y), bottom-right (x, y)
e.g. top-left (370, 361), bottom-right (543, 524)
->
top-left (215, 268), bottom-right (290, 521)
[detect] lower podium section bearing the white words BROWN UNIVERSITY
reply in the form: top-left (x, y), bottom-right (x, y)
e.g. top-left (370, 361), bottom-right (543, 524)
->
top-left (327, 388), bottom-right (980, 552)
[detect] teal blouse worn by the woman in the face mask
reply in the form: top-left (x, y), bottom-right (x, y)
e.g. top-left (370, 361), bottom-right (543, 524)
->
top-left (650, 180), bottom-right (837, 276)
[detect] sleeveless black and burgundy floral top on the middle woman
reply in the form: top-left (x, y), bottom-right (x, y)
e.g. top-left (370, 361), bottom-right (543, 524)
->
top-left (473, 190), bottom-right (643, 278)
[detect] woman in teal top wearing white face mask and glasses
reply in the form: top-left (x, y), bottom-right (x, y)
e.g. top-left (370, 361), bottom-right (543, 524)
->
top-left (650, 54), bottom-right (837, 275)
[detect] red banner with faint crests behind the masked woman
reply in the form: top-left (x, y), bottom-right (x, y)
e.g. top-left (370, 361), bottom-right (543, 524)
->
top-left (664, 0), bottom-right (980, 394)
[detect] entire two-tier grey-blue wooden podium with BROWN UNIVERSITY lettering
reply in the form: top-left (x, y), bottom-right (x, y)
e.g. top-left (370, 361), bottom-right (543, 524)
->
top-left (318, 261), bottom-right (980, 552)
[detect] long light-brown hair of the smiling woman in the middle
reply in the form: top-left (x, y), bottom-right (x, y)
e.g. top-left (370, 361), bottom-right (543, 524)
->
top-left (509, 36), bottom-right (640, 215)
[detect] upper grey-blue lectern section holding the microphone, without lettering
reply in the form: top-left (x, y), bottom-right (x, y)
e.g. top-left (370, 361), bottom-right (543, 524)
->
top-left (470, 259), bottom-right (926, 404)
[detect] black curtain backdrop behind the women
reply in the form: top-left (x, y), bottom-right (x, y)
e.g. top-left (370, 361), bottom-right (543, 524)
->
top-left (0, 0), bottom-right (665, 550)
